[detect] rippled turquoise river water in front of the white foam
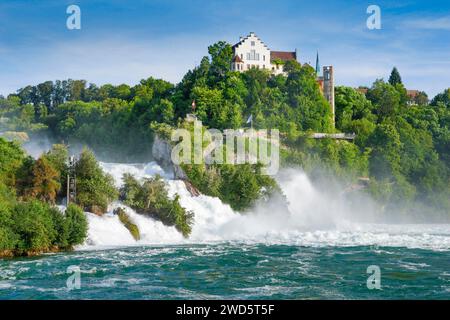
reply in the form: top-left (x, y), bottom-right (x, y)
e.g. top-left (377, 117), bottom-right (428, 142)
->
top-left (0, 243), bottom-right (450, 299)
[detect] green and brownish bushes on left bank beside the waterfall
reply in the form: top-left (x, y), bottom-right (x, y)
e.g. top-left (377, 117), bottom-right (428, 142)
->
top-left (0, 138), bottom-right (110, 256)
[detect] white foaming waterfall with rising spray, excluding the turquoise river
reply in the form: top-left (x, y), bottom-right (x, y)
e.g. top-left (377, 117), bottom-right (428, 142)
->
top-left (75, 162), bottom-right (450, 250)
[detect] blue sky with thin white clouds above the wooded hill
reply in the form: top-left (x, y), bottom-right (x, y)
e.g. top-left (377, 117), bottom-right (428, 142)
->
top-left (0, 0), bottom-right (450, 96)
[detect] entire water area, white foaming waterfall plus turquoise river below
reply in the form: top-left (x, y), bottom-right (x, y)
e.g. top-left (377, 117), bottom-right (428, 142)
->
top-left (0, 163), bottom-right (450, 299)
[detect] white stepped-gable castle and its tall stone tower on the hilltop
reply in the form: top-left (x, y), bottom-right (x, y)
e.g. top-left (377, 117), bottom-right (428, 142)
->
top-left (231, 32), bottom-right (335, 125)
